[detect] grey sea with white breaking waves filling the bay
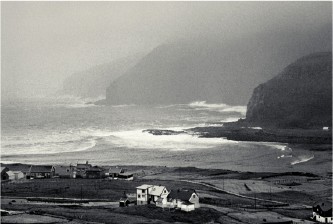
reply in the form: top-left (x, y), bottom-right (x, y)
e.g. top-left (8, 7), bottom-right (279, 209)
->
top-left (1, 96), bottom-right (314, 172)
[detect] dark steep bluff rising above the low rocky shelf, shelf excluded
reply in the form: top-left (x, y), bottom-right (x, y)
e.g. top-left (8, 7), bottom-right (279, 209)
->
top-left (246, 52), bottom-right (332, 128)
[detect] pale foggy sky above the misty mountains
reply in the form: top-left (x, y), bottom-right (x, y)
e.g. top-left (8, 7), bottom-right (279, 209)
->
top-left (1, 2), bottom-right (332, 99)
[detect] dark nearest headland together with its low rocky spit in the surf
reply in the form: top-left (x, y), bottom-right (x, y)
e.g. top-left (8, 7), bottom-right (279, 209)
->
top-left (146, 52), bottom-right (332, 144)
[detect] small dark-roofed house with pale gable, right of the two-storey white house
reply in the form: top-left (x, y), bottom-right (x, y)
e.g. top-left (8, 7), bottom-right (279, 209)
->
top-left (168, 189), bottom-right (200, 209)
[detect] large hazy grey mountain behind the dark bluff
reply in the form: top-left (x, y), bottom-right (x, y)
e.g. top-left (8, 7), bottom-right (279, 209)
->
top-left (106, 26), bottom-right (332, 105)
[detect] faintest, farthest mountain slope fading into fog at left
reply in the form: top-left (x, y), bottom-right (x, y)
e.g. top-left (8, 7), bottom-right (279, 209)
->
top-left (62, 54), bottom-right (144, 98)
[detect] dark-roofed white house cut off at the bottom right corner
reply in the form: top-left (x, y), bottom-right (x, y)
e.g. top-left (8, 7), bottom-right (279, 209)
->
top-left (312, 202), bottom-right (333, 223)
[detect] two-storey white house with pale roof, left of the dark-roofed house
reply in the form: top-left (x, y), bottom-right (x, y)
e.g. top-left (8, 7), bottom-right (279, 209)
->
top-left (136, 184), bottom-right (169, 205)
